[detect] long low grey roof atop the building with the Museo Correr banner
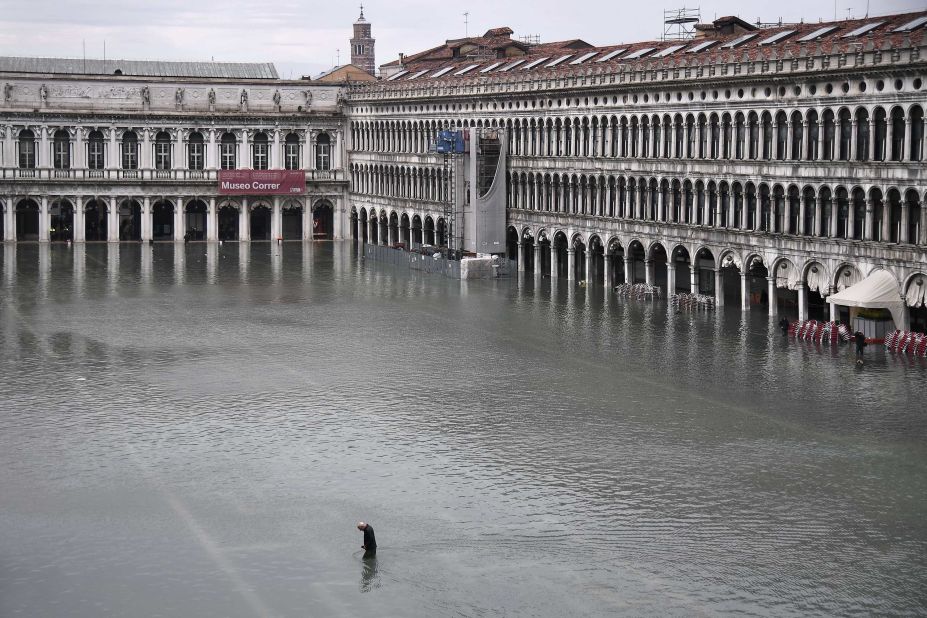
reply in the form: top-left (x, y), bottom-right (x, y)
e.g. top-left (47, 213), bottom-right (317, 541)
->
top-left (0, 56), bottom-right (280, 79)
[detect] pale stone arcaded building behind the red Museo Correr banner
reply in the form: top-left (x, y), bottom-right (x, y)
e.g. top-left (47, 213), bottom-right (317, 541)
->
top-left (0, 58), bottom-right (347, 242)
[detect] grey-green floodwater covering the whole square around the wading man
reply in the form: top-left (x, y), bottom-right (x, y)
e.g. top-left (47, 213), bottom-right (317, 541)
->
top-left (0, 243), bottom-right (927, 618)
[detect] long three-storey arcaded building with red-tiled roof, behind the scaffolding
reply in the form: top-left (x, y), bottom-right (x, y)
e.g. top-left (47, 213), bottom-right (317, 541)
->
top-left (347, 13), bottom-right (927, 326)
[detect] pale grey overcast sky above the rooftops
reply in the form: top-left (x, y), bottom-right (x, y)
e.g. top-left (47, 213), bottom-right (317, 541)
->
top-left (0, 0), bottom-right (927, 78)
